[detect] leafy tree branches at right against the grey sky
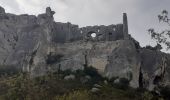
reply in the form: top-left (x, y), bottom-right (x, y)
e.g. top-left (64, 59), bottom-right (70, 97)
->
top-left (148, 10), bottom-right (170, 50)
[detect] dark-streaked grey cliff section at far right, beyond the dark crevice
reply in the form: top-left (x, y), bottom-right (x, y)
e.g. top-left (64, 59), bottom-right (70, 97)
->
top-left (140, 48), bottom-right (170, 90)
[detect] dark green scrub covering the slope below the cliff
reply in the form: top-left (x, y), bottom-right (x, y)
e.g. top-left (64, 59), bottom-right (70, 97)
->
top-left (0, 67), bottom-right (168, 100)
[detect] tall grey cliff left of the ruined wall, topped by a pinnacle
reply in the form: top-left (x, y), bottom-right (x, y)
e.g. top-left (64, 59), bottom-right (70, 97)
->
top-left (0, 8), bottom-right (53, 75)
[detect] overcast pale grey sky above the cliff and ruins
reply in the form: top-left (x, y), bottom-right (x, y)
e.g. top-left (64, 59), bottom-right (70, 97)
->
top-left (0, 0), bottom-right (170, 51)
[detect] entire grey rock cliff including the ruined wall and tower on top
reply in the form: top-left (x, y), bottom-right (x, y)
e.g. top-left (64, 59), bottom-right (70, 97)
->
top-left (0, 7), bottom-right (170, 89)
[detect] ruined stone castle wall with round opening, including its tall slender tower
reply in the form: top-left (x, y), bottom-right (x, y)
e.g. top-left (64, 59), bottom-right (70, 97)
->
top-left (45, 14), bottom-right (128, 43)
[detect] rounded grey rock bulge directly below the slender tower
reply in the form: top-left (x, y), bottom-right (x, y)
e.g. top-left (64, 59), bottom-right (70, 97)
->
top-left (105, 40), bottom-right (140, 87)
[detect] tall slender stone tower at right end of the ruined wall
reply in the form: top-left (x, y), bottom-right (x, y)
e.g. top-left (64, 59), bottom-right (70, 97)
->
top-left (123, 13), bottom-right (129, 39)
